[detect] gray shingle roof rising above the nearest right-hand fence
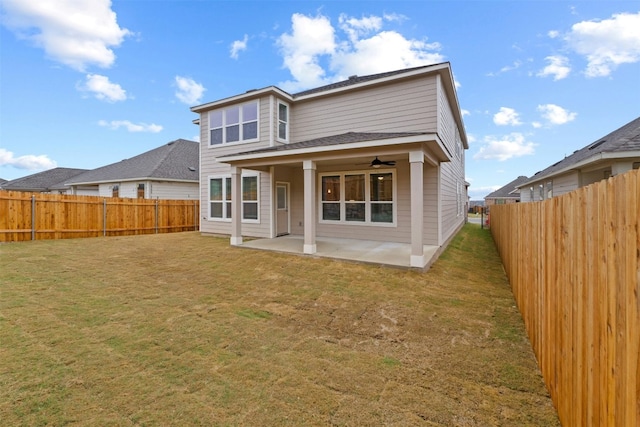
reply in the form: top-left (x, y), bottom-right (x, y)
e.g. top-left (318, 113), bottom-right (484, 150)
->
top-left (522, 117), bottom-right (640, 184)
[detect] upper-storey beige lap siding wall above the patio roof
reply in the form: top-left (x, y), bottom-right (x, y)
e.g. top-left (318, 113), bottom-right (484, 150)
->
top-left (291, 77), bottom-right (437, 142)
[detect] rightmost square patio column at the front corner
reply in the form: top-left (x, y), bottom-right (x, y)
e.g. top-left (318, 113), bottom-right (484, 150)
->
top-left (409, 151), bottom-right (425, 268)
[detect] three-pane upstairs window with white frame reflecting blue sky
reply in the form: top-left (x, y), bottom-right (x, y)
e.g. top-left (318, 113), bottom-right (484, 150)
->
top-left (209, 101), bottom-right (258, 146)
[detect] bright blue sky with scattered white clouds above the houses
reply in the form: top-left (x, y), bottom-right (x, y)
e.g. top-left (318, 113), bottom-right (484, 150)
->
top-left (0, 0), bottom-right (640, 200)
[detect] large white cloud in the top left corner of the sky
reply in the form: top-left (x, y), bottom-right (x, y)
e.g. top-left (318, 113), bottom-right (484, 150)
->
top-left (2, 0), bottom-right (131, 71)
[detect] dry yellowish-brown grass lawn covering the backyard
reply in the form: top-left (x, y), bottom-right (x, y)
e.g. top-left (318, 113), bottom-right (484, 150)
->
top-left (0, 225), bottom-right (559, 426)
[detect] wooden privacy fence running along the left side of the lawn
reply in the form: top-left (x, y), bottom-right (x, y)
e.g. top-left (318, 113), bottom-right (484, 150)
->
top-left (0, 191), bottom-right (199, 242)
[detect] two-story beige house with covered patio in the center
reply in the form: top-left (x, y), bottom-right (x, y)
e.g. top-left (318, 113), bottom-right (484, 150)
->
top-left (192, 63), bottom-right (468, 267)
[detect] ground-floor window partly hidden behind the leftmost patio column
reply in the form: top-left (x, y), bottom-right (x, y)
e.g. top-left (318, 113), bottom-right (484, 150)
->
top-left (209, 175), bottom-right (260, 222)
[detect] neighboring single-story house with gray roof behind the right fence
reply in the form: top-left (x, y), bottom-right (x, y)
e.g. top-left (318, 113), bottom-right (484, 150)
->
top-left (519, 117), bottom-right (640, 202)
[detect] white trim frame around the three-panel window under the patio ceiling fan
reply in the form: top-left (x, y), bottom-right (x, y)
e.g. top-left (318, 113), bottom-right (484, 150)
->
top-left (317, 169), bottom-right (398, 227)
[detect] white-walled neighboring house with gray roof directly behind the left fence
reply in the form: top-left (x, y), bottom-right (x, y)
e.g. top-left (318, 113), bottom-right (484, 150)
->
top-left (65, 139), bottom-right (199, 199)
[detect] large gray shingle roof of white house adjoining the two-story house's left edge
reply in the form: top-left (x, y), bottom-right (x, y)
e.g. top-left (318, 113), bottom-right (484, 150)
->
top-left (66, 139), bottom-right (200, 184)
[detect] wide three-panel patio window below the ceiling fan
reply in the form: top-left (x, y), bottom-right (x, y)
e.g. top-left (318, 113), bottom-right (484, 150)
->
top-left (320, 170), bottom-right (396, 225)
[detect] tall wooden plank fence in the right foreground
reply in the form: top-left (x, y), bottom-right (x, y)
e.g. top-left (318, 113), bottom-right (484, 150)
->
top-left (491, 170), bottom-right (640, 427)
